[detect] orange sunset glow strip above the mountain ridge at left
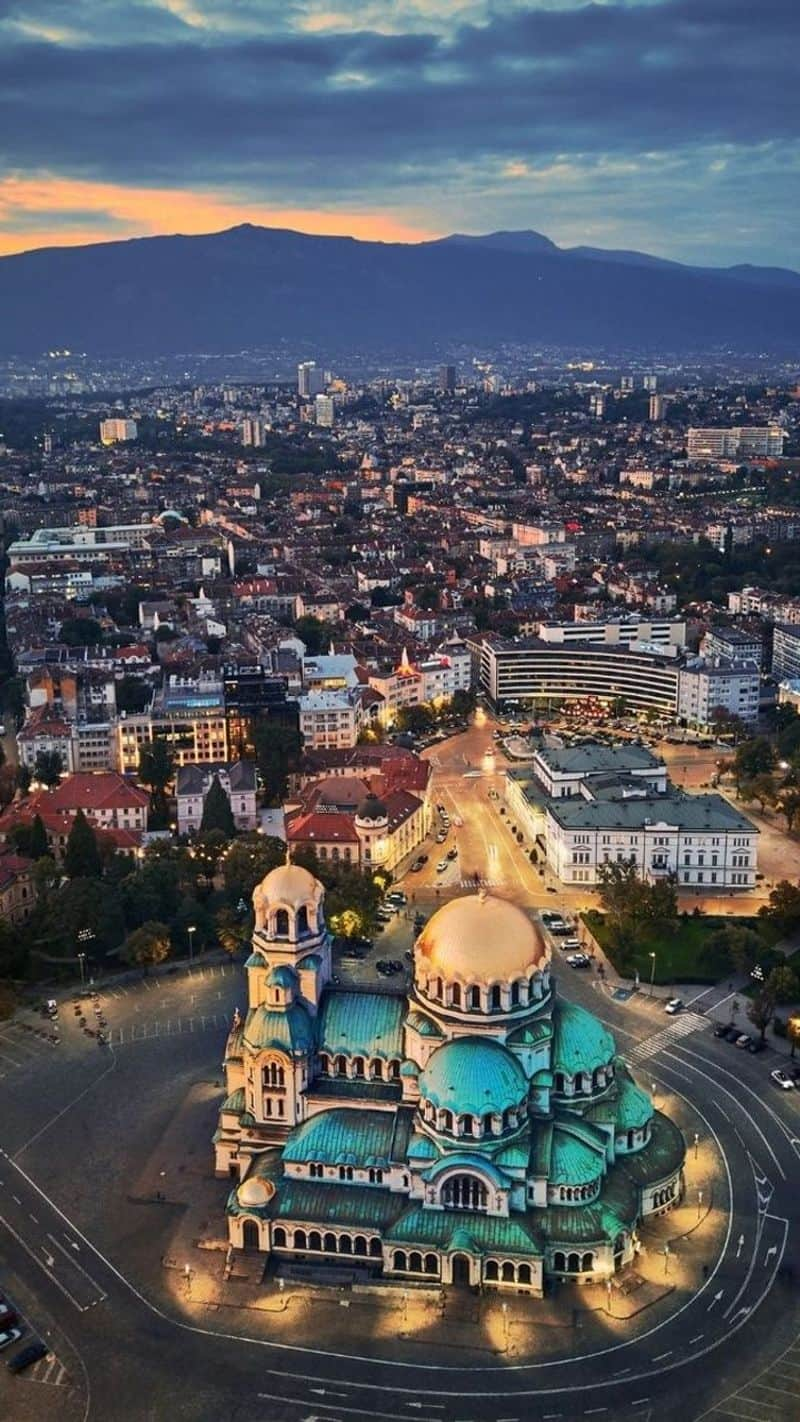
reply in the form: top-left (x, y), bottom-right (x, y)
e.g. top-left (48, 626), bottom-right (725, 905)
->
top-left (0, 173), bottom-right (433, 256)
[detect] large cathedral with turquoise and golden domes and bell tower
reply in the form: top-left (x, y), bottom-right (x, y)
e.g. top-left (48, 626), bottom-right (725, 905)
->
top-left (215, 863), bottom-right (685, 1294)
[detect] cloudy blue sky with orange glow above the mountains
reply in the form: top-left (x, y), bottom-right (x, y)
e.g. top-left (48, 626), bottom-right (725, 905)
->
top-left (0, 0), bottom-right (800, 267)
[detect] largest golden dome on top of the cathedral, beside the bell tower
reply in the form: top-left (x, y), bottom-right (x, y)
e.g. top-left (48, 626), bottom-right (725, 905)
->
top-left (415, 893), bottom-right (550, 984)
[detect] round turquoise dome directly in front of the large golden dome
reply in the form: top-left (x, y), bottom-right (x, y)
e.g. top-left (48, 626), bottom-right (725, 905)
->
top-left (419, 1037), bottom-right (527, 1116)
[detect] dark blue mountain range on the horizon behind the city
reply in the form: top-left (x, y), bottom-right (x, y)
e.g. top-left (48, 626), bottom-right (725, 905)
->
top-left (0, 223), bottom-right (800, 357)
